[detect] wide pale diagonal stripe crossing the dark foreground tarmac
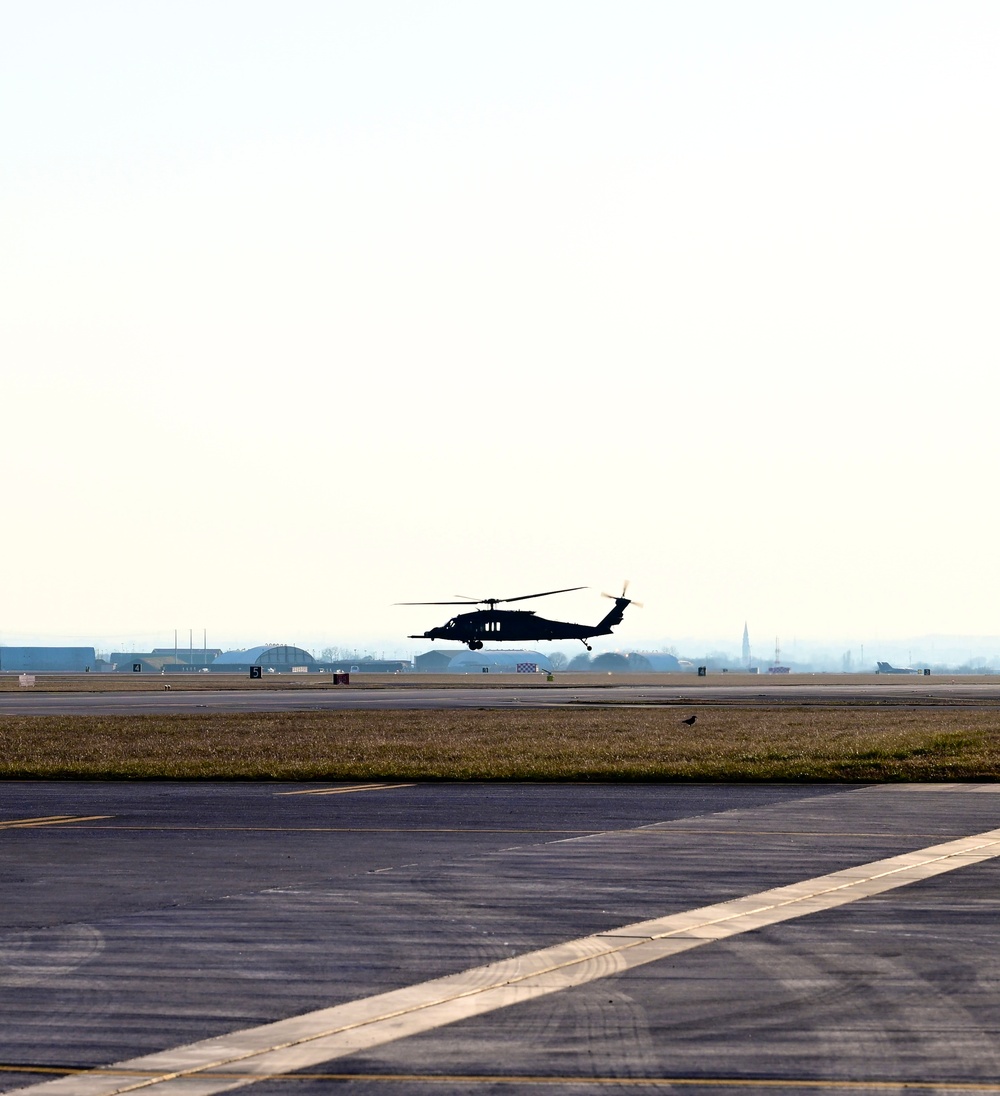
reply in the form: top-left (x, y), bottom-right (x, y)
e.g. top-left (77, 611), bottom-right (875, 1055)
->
top-left (16, 830), bottom-right (1000, 1096)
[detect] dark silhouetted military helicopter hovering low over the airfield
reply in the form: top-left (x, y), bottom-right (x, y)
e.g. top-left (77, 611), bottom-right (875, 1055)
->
top-left (396, 582), bottom-right (639, 651)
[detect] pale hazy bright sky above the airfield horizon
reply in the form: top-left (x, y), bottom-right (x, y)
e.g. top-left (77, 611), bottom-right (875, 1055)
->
top-left (0, 0), bottom-right (1000, 651)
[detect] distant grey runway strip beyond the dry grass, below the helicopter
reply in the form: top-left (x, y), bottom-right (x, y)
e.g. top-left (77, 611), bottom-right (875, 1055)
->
top-left (0, 677), bottom-right (1000, 716)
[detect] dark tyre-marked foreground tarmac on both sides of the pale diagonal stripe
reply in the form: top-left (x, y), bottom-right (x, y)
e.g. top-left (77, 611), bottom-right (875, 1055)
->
top-left (0, 781), bottom-right (1000, 1096)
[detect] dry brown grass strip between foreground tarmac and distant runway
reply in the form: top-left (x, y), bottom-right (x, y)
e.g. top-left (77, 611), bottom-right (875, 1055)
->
top-left (0, 705), bottom-right (1000, 781)
